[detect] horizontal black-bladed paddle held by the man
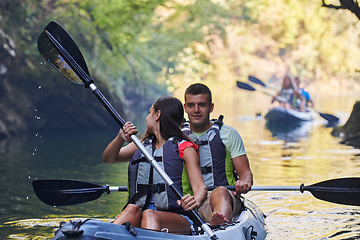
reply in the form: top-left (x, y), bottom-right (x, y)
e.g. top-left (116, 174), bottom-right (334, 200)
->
top-left (33, 178), bottom-right (360, 206)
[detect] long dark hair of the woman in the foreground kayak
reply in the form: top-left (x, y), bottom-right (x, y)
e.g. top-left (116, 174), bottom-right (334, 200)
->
top-left (153, 97), bottom-right (192, 142)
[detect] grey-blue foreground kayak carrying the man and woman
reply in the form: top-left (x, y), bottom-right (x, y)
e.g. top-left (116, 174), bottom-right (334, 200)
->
top-left (53, 198), bottom-right (267, 240)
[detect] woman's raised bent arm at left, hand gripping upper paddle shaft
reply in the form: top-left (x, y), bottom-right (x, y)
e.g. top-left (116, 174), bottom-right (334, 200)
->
top-left (103, 122), bottom-right (138, 164)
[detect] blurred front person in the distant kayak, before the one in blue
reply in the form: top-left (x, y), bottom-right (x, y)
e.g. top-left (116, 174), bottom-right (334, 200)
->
top-left (271, 76), bottom-right (305, 112)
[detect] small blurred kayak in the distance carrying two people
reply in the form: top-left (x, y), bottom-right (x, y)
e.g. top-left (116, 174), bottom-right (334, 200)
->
top-left (265, 107), bottom-right (317, 124)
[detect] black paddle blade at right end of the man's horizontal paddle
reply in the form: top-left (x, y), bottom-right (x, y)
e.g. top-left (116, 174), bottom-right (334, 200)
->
top-left (300, 178), bottom-right (360, 206)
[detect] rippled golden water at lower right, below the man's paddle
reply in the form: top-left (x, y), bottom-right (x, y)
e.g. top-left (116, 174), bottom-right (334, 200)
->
top-left (252, 192), bottom-right (360, 240)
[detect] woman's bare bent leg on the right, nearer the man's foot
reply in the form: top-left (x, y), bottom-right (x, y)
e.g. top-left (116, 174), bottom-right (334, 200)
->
top-left (141, 209), bottom-right (191, 235)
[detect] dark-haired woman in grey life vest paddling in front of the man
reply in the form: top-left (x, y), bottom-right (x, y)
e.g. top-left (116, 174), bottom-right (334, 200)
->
top-left (103, 97), bottom-right (207, 234)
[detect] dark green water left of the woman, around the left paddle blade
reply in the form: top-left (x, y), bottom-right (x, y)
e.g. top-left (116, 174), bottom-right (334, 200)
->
top-left (0, 133), bottom-right (127, 239)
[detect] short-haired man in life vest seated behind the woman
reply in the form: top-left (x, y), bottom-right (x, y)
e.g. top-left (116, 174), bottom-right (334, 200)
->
top-left (182, 83), bottom-right (253, 225)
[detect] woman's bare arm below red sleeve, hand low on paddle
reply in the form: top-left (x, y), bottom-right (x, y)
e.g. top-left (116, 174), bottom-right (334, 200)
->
top-left (181, 147), bottom-right (207, 210)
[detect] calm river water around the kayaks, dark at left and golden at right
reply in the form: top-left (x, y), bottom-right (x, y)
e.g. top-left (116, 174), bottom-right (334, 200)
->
top-left (0, 81), bottom-right (360, 239)
